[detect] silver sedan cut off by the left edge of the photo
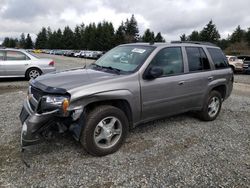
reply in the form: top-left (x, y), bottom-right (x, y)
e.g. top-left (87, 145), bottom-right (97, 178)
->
top-left (0, 48), bottom-right (56, 79)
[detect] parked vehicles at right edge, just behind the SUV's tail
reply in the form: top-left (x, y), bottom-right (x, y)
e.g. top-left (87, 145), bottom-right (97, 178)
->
top-left (226, 55), bottom-right (250, 73)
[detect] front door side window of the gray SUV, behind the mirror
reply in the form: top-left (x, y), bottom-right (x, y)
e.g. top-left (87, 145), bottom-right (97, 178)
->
top-left (150, 47), bottom-right (183, 76)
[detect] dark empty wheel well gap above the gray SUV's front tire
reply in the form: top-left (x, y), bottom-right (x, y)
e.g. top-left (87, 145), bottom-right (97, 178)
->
top-left (85, 99), bottom-right (133, 128)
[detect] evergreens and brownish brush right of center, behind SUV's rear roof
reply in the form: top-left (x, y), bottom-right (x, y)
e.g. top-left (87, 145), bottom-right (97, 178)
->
top-left (180, 20), bottom-right (250, 54)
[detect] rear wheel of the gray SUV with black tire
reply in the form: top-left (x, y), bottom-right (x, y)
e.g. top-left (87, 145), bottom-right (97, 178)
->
top-left (198, 90), bottom-right (222, 121)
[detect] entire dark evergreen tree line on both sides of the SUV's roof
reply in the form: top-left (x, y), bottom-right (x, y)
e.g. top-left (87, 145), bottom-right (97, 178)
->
top-left (2, 15), bottom-right (250, 54)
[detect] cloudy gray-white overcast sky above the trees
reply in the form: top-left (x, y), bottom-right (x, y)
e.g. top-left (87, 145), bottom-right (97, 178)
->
top-left (0, 0), bottom-right (250, 44)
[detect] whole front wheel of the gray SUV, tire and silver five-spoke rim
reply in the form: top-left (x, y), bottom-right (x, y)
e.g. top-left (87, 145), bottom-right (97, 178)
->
top-left (80, 105), bottom-right (129, 156)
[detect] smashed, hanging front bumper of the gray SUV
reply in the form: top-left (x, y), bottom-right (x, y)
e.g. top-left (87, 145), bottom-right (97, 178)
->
top-left (19, 95), bottom-right (85, 148)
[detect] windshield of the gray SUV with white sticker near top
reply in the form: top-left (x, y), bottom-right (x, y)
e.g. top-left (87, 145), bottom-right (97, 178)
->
top-left (91, 45), bottom-right (155, 73)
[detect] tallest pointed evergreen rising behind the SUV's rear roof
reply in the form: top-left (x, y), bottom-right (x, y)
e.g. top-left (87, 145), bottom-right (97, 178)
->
top-left (200, 20), bottom-right (220, 43)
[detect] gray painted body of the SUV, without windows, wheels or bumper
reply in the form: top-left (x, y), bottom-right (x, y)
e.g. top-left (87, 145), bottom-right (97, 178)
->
top-left (26, 44), bottom-right (232, 126)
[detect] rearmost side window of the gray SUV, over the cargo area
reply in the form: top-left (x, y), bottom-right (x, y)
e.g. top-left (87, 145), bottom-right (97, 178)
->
top-left (207, 48), bottom-right (228, 69)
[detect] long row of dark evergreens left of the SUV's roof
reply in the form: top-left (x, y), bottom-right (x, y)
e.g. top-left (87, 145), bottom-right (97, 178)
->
top-left (2, 15), bottom-right (165, 51)
